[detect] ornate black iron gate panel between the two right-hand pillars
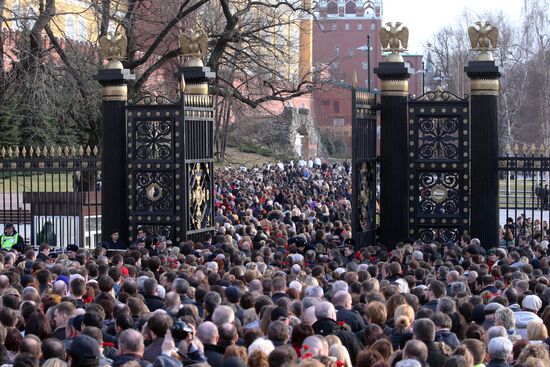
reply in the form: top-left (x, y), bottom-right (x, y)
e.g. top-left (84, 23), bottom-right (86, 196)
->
top-left (408, 88), bottom-right (470, 243)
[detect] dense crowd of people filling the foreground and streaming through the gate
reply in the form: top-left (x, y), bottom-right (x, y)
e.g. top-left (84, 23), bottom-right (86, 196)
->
top-left (0, 162), bottom-right (550, 367)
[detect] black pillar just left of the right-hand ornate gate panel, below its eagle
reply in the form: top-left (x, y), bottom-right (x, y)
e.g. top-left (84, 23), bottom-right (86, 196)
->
top-left (374, 56), bottom-right (413, 249)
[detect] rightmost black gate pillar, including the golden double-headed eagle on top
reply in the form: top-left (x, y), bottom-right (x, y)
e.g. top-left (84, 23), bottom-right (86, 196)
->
top-left (464, 24), bottom-right (500, 248)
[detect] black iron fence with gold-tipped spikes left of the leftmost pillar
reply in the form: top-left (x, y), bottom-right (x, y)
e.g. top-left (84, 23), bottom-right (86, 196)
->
top-left (0, 146), bottom-right (101, 250)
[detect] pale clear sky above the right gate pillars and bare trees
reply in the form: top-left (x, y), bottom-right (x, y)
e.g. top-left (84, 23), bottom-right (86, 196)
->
top-left (382, 0), bottom-right (528, 53)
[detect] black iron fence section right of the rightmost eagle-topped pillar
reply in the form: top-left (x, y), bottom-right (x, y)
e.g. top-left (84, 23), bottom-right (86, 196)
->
top-left (498, 144), bottom-right (550, 237)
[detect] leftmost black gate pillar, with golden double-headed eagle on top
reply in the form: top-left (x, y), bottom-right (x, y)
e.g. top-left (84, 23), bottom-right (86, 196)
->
top-left (94, 36), bottom-right (135, 242)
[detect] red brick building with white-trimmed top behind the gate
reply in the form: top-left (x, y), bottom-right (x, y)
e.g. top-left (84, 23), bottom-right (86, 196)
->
top-left (311, 0), bottom-right (422, 144)
